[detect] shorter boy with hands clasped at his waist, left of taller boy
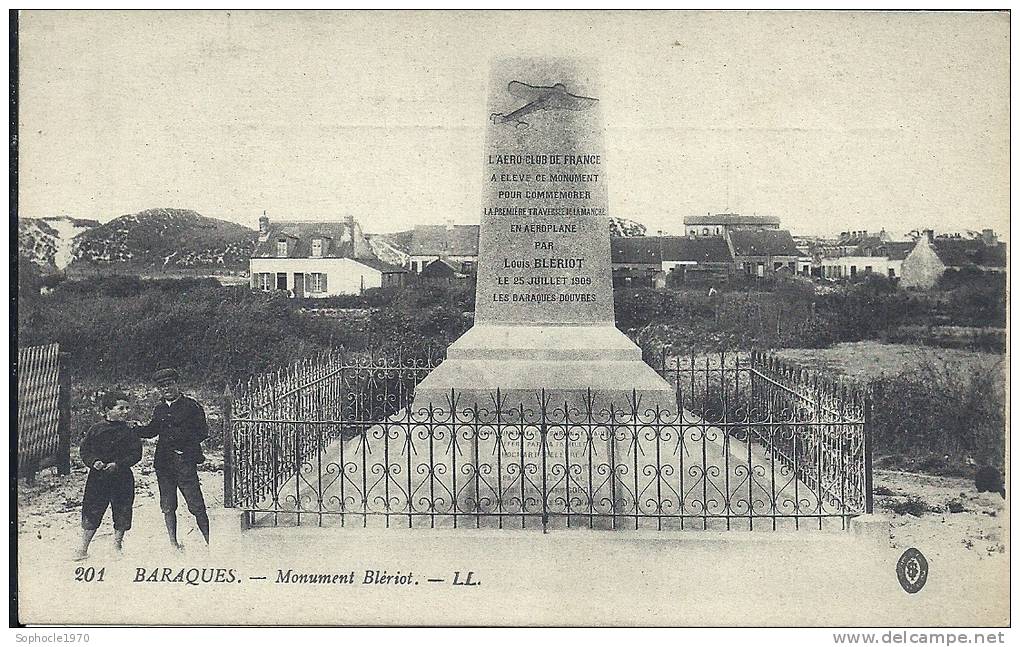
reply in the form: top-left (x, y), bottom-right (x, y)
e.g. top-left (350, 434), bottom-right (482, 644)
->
top-left (74, 391), bottom-right (142, 560)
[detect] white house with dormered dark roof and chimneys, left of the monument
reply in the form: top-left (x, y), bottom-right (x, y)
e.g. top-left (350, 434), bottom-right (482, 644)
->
top-left (249, 216), bottom-right (406, 298)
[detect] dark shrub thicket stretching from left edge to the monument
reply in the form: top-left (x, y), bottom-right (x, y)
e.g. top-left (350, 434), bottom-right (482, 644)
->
top-left (18, 276), bottom-right (470, 390)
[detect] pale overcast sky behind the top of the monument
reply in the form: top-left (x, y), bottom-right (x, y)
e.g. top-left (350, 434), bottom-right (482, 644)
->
top-left (18, 11), bottom-right (1009, 234)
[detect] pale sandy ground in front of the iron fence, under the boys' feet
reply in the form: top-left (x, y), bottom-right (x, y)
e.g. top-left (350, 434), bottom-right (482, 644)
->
top-left (18, 449), bottom-right (1009, 626)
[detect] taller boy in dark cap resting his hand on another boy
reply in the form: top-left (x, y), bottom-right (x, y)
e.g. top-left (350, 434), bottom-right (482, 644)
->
top-left (136, 368), bottom-right (209, 550)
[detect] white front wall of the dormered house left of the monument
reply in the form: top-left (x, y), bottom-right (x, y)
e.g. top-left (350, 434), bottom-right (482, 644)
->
top-left (250, 258), bottom-right (383, 298)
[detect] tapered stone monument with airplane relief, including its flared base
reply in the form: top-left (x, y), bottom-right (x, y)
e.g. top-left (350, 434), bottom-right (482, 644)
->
top-left (414, 59), bottom-right (676, 410)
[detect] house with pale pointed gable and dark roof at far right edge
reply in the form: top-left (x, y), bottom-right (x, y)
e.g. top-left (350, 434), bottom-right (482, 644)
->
top-left (900, 230), bottom-right (1007, 290)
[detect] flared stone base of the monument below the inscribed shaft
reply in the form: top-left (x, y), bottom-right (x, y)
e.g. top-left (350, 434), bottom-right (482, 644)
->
top-left (414, 324), bottom-right (676, 412)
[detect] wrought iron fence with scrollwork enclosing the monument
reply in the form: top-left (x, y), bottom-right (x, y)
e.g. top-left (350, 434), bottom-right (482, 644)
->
top-left (224, 346), bottom-right (870, 530)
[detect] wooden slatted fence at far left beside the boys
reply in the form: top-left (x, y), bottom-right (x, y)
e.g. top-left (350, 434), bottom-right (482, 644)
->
top-left (16, 344), bottom-right (70, 482)
